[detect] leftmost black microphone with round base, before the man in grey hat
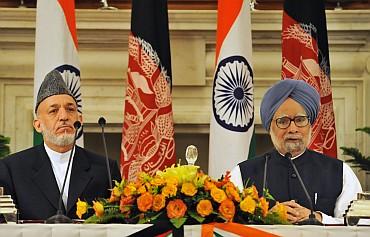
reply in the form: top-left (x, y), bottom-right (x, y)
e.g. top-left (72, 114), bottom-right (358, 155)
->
top-left (45, 121), bottom-right (81, 224)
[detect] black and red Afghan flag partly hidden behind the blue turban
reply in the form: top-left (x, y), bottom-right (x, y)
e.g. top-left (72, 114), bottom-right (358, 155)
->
top-left (281, 0), bottom-right (337, 158)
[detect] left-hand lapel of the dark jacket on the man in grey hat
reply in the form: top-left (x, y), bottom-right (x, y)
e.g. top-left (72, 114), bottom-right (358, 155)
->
top-left (31, 145), bottom-right (60, 209)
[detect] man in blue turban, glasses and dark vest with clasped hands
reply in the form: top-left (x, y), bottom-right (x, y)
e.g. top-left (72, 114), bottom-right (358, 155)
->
top-left (231, 79), bottom-right (362, 224)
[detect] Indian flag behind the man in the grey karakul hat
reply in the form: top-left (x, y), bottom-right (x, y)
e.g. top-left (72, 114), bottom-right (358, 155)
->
top-left (34, 0), bottom-right (83, 146)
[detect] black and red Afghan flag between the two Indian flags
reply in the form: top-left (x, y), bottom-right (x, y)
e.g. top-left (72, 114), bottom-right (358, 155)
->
top-left (121, 0), bottom-right (176, 180)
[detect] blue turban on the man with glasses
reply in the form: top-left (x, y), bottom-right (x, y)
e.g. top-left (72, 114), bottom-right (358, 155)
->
top-left (260, 79), bottom-right (320, 131)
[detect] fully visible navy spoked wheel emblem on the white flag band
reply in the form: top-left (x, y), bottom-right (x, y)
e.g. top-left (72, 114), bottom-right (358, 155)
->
top-left (212, 56), bottom-right (254, 132)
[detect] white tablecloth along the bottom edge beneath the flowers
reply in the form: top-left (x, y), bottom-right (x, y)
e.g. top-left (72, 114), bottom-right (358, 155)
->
top-left (0, 224), bottom-right (370, 237)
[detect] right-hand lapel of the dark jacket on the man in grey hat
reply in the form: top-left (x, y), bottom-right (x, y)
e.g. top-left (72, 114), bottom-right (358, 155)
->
top-left (67, 146), bottom-right (92, 213)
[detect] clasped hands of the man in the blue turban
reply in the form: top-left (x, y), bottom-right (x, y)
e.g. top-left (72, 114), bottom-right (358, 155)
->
top-left (281, 200), bottom-right (322, 223)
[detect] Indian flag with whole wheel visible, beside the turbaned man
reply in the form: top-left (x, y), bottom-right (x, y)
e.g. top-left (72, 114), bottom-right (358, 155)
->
top-left (208, 0), bottom-right (254, 177)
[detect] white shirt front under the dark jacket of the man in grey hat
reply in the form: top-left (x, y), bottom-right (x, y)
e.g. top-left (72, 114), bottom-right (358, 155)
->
top-left (44, 143), bottom-right (75, 208)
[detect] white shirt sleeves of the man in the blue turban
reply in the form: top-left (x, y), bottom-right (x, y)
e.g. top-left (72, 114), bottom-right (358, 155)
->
top-left (231, 159), bottom-right (368, 224)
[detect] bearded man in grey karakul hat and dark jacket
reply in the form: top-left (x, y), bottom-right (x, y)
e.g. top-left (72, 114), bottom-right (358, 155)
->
top-left (0, 70), bottom-right (121, 220)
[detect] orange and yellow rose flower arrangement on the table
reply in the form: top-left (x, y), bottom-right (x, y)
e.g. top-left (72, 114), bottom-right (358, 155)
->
top-left (76, 165), bottom-right (288, 228)
